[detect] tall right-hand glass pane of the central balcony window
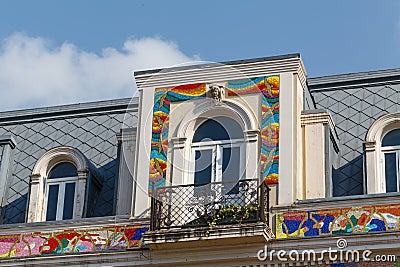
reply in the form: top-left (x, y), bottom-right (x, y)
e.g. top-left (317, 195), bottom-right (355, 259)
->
top-left (222, 147), bottom-right (240, 194)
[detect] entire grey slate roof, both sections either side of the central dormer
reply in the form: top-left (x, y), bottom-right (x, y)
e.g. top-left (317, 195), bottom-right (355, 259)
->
top-left (0, 61), bottom-right (400, 223)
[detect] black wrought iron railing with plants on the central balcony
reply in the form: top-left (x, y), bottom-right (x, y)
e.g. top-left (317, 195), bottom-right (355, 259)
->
top-left (151, 179), bottom-right (269, 230)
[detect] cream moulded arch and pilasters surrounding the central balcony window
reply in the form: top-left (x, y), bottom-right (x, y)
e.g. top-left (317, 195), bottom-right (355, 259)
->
top-left (170, 99), bottom-right (261, 185)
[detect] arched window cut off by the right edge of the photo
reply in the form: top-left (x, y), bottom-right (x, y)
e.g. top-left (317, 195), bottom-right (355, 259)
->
top-left (381, 129), bottom-right (400, 192)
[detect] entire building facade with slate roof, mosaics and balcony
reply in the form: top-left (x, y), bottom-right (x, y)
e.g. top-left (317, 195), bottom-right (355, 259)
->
top-left (0, 54), bottom-right (400, 266)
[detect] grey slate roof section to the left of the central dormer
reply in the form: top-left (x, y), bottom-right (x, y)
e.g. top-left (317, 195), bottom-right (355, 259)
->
top-left (0, 99), bottom-right (138, 223)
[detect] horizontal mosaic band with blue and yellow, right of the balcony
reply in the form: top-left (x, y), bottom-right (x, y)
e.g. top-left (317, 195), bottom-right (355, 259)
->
top-left (276, 204), bottom-right (400, 238)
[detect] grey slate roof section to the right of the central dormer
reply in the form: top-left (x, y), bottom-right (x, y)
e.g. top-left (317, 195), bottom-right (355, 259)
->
top-left (308, 69), bottom-right (400, 196)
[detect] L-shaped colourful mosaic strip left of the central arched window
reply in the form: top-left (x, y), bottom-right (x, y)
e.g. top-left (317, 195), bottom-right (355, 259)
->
top-left (149, 83), bottom-right (207, 194)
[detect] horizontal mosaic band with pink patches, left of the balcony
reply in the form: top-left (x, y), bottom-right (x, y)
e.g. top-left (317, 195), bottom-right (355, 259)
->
top-left (0, 225), bottom-right (149, 258)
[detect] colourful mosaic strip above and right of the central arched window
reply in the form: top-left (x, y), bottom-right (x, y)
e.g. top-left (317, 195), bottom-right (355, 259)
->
top-left (228, 76), bottom-right (279, 184)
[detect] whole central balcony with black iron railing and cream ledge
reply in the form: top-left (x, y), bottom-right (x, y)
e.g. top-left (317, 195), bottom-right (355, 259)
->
top-left (144, 179), bottom-right (272, 248)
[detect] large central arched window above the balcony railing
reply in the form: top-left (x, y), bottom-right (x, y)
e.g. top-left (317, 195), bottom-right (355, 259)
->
top-left (191, 116), bottom-right (244, 193)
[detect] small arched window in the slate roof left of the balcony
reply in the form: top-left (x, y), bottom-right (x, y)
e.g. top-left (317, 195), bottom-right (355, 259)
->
top-left (44, 162), bottom-right (78, 221)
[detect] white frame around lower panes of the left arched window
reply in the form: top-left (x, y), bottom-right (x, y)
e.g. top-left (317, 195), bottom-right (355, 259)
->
top-left (43, 176), bottom-right (78, 221)
